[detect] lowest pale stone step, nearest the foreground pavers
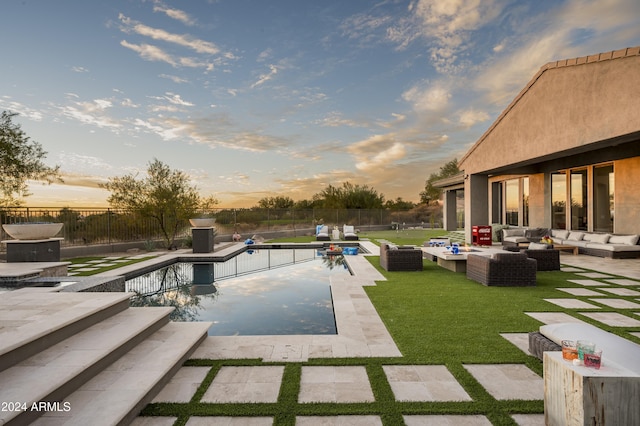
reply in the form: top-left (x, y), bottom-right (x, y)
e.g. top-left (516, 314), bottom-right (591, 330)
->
top-left (33, 322), bottom-right (211, 426)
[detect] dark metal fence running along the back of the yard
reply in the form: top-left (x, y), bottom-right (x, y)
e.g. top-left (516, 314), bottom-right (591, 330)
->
top-left (0, 207), bottom-right (440, 250)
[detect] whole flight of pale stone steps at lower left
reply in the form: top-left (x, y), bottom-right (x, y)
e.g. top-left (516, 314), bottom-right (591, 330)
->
top-left (0, 289), bottom-right (211, 425)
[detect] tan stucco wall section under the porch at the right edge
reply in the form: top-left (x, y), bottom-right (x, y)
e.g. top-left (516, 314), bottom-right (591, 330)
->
top-left (613, 157), bottom-right (640, 234)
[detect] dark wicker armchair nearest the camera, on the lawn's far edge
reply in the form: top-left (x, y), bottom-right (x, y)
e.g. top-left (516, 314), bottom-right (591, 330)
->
top-left (467, 253), bottom-right (537, 287)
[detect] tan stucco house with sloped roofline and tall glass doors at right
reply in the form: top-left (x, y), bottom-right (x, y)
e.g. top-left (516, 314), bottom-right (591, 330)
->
top-left (438, 46), bottom-right (640, 242)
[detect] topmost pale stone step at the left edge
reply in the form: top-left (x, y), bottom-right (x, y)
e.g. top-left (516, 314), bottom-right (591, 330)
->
top-left (0, 288), bottom-right (132, 371)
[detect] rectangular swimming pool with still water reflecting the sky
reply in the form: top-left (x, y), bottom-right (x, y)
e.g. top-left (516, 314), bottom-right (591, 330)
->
top-left (125, 248), bottom-right (350, 336)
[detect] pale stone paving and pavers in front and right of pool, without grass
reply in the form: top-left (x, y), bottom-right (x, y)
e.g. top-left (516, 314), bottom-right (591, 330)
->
top-left (1, 241), bottom-right (640, 426)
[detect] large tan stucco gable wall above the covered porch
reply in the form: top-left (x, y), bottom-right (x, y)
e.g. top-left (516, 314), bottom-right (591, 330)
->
top-left (460, 56), bottom-right (640, 174)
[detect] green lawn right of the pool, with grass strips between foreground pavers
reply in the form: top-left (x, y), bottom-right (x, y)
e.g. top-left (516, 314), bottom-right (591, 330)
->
top-left (92, 230), bottom-right (640, 426)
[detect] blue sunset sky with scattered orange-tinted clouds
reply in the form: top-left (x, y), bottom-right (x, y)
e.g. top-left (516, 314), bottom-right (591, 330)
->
top-left (0, 0), bottom-right (640, 207)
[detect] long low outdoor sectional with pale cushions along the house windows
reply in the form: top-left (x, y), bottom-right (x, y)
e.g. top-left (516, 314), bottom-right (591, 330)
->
top-left (502, 228), bottom-right (640, 259)
